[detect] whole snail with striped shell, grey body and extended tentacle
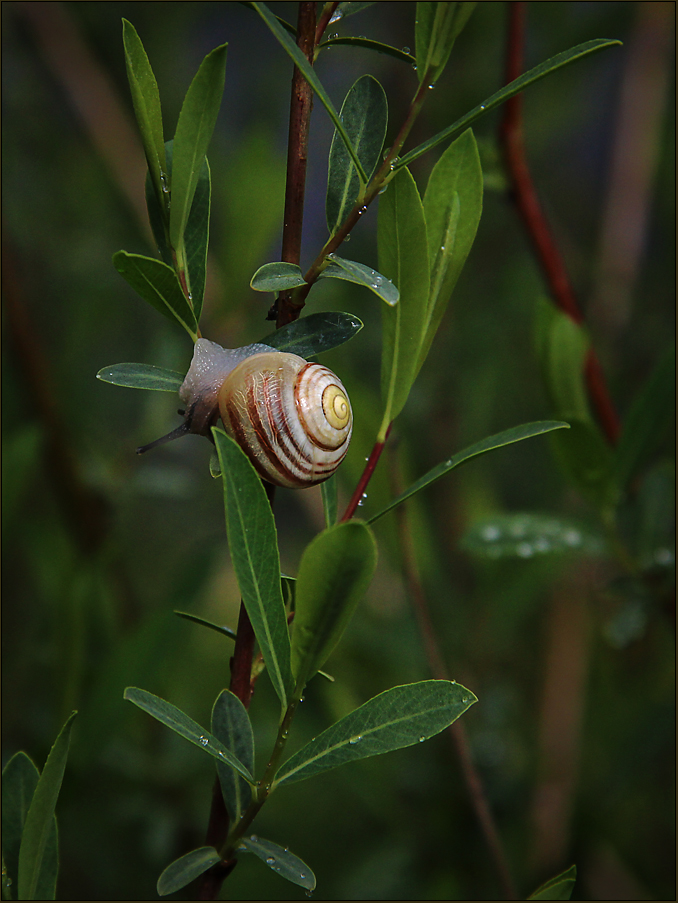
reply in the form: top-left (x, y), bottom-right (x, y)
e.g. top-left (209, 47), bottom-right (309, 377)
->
top-left (137, 339), bottom-right (353, 489)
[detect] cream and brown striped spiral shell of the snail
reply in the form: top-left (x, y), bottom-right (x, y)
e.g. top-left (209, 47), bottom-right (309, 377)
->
top-left (219, 352), bottom-right (353, 489)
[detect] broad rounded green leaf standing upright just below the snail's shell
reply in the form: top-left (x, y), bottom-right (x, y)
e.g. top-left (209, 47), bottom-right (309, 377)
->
top-left (292, 520), bottom-right (377, 690)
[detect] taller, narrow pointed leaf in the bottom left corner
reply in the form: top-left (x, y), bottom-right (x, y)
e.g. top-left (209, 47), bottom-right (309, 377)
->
top-left (17, 712), bottom-right (77, 900)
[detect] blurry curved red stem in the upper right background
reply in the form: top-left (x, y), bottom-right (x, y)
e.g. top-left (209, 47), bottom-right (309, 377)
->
top-left (499, 0), bottom-right (620, 445)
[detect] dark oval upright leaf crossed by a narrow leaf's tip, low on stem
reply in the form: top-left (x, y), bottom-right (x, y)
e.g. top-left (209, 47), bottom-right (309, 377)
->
top-left (212, 690), bottom-right (254, 824)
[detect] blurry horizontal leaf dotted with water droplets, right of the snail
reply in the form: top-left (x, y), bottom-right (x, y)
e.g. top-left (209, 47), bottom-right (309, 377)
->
top-left (461, 511), bottom-right (606, 558)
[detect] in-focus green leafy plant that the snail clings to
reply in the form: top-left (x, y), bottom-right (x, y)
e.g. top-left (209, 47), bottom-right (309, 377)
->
top-left (89, 3), bottom-right (636, 897)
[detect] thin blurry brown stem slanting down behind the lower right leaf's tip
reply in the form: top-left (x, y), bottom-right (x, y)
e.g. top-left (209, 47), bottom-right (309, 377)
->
top-left (390, 448), bottom-right (518, 900)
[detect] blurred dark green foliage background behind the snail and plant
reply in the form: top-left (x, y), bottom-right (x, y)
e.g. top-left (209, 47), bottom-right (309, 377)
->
top-left (2, 2), bottom-right (675, 899)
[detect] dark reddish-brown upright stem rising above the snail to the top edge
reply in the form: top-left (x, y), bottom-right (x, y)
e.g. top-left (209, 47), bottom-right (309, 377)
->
top-left (272, 2), bottom-right (316, 329)
